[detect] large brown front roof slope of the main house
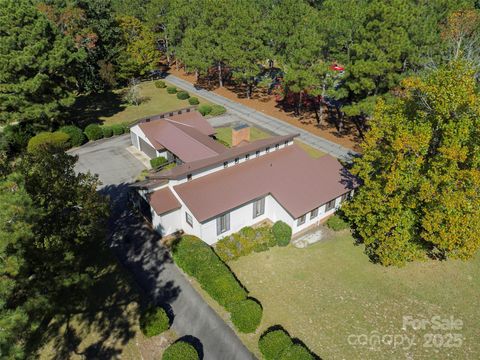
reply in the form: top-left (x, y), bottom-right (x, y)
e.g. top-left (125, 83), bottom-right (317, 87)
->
top-left (174, 145), bottom-right (353, 222)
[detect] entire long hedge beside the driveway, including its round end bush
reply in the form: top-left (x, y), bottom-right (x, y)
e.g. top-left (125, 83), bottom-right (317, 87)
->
top-left (173, 235), bottom-right (262, 332)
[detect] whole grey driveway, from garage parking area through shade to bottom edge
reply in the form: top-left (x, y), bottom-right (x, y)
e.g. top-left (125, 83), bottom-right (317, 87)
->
top-left (70, 135), bottom-right (255, 360)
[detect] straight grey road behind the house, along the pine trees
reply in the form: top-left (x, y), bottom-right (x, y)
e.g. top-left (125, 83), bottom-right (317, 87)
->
top-left (165, 75), bottom-right (356, 161)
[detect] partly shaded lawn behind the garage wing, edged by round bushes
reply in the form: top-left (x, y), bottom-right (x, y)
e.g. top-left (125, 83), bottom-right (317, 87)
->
top-left (72, 81), bottom-right (209, 125)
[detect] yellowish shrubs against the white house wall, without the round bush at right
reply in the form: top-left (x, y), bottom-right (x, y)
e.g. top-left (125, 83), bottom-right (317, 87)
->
top-left (215, 226), bottom-right (276, 261)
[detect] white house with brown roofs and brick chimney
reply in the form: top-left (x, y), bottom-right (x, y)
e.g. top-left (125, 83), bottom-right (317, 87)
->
top-left (129, 112), bottom-right (354, 244)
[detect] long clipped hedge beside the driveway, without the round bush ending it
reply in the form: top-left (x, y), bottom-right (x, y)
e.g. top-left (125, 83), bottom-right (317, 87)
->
top-left (173, 235), bottom-right (247, 310)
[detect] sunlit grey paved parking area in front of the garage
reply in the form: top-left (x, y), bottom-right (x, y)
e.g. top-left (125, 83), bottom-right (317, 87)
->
top-left (69, 134), bottom-right (145, 186)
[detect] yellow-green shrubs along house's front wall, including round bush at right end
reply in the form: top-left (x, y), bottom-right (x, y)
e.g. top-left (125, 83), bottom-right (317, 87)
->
top-left (215, 221), bottom-right (292, 262)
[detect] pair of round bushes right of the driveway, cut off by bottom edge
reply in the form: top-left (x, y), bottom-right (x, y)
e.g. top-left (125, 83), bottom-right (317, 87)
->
top-left (258, 328), bottom-right (314, 360)
